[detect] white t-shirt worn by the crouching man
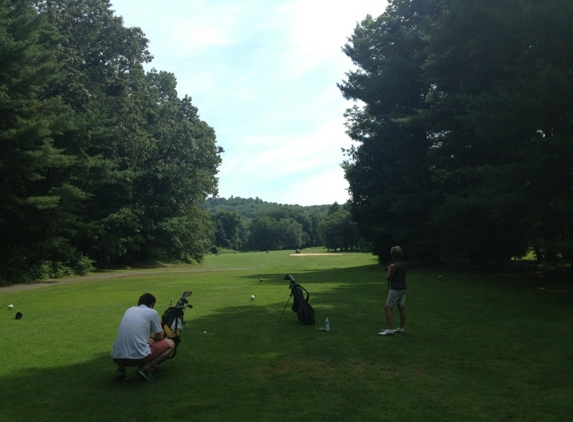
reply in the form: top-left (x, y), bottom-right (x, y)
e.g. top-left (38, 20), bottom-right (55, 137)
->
top-left (111, 305), bottom-right (161, 359)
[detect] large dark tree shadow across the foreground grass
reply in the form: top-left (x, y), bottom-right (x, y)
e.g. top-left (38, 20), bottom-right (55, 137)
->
top-left (0, 265), bottom-right (571, 422)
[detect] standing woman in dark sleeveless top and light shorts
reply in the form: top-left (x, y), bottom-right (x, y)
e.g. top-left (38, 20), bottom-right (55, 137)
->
top-left (378, 246), bottom-right (408, 336)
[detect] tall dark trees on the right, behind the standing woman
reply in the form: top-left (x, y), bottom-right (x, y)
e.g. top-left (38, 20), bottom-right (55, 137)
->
top-left (339, 0), bottom-right (573, 264)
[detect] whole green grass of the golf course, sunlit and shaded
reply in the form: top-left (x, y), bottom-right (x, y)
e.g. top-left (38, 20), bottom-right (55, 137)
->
top-left (0, 249), bottom-right (573, 422)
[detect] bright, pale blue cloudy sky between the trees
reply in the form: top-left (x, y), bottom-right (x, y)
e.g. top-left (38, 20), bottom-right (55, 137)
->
top-left (111, 0), bottom-right (387, 206)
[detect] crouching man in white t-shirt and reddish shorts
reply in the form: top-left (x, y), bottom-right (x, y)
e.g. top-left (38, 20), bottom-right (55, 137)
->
top-left (111, 293), bottom-right (175, 381)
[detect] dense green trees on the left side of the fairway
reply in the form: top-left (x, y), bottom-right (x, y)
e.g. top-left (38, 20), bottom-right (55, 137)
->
top-left (0, 0), bottom-right (222, 284)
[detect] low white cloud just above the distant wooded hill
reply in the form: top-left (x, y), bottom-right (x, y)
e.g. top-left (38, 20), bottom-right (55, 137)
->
top-left (214, 111), bottom-right (348, 205)
